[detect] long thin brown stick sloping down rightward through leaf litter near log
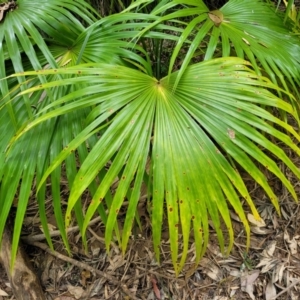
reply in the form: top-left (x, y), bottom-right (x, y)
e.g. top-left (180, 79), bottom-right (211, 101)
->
top-left (26, 240), bottom-right (138, 300)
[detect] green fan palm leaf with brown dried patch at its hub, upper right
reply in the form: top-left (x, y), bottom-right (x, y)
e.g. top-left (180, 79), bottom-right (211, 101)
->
top-left (140, 0), bottom-right (300, 106)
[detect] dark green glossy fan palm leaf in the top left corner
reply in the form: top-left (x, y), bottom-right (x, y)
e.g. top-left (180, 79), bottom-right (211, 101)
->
top-left (0, 0), bottom-right (95, 123)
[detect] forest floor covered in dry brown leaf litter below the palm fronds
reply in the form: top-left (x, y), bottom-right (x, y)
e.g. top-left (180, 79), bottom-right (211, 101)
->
top-left (0, 148), bottom-right (300, 300)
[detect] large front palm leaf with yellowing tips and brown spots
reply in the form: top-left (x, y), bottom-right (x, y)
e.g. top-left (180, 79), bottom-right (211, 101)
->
top-left (7, 58), bottom-right (300, 273)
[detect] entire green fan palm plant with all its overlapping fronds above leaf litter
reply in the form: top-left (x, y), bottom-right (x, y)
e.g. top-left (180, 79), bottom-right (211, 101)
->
top-left (0, 0), bottom-right (300, 273)
